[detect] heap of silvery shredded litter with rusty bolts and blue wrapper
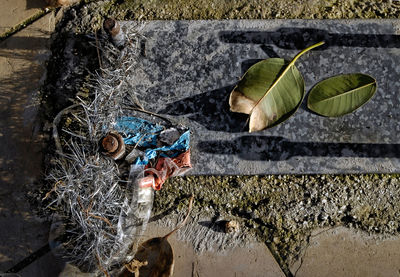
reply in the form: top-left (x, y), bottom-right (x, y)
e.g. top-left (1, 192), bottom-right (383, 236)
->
top-left (44, 20), bottom-right (191, 275)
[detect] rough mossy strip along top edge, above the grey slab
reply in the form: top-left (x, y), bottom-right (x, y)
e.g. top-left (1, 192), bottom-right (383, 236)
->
top-left (114, 0), bottom-right (399, 20)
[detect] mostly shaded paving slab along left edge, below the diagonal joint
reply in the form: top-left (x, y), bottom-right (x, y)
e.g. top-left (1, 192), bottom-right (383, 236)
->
top-left (0, 11), bottom-right (55, 276)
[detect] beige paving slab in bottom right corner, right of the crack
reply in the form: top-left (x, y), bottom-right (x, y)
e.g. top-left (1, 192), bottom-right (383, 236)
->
top-left (292, 227), bottom-right (400, 277)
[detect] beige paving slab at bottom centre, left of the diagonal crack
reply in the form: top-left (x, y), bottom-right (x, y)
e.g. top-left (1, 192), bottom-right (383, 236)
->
top-left (143, 218), bottom-right (285, 277)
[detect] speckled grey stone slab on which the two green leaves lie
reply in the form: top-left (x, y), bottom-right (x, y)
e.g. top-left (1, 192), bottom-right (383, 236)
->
top-left (122, 20), bottom-right (400, 175)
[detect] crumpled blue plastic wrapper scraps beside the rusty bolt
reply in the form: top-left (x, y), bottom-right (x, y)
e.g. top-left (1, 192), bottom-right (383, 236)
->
top-left (115, 117), bottom-right (190, 165)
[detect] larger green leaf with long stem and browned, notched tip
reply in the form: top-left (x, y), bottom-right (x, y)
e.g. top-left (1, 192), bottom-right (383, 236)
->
top-left (229, 42), bottom-right (324, 132)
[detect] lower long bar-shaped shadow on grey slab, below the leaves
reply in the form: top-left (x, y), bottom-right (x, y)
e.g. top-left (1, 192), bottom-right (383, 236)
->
top-left (197, 136), bottom-right (400, 161)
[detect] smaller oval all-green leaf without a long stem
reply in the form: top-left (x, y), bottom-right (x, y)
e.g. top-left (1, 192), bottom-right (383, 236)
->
top-left (307, 73), bottom-right (377, 117)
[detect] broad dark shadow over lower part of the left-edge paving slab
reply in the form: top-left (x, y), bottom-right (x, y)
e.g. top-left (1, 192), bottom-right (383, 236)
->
top-left (0, 66), bottom-right (52, 270)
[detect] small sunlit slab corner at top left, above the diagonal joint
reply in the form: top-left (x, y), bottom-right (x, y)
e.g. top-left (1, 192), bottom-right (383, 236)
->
top-left (0, 0), bottom-right (46, 34)
